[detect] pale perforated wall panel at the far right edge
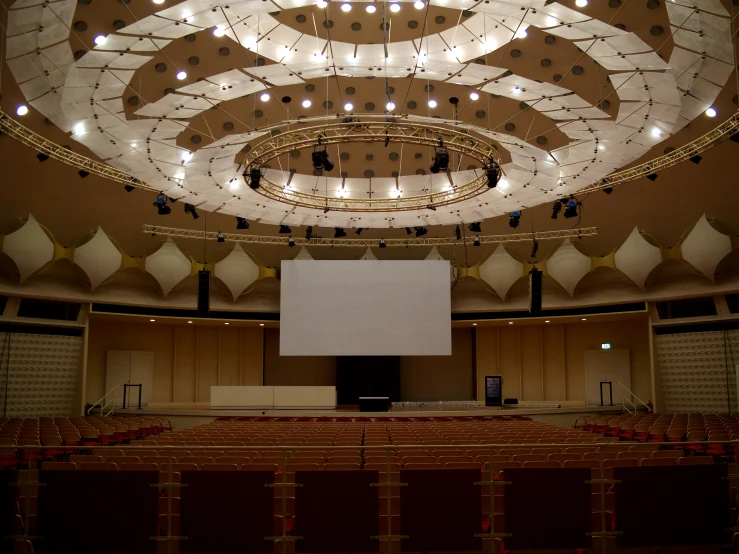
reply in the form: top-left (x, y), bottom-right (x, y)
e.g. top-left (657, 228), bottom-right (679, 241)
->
top-left (655, 331), bottom-right (739, 413)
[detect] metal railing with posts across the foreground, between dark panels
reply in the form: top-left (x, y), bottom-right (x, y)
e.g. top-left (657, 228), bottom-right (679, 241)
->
top-left (0, 440), bottom-right (739, 554)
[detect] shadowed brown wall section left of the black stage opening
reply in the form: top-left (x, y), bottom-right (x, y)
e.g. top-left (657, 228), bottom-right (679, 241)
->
top-left (264, 329), bottom-right (336, 387)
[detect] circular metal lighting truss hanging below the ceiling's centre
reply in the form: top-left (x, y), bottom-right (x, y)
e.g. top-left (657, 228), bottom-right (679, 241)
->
top-left (244, 118), bottom-right (502, 212)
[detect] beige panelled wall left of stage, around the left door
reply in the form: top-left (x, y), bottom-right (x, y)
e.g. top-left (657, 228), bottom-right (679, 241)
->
top-left (86, 319), bottom-right (264, 402)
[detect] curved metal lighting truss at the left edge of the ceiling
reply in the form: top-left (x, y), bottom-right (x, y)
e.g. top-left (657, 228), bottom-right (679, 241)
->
top-left (0, 110), bottom-right (159, 192)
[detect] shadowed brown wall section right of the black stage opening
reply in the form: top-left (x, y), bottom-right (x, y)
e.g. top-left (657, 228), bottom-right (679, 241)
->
top-left (400, 328), bottom-right (474, 402)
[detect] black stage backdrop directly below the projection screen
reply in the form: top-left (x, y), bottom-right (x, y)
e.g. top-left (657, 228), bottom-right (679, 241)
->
top-left (336, 356), bottom-right (400, 406)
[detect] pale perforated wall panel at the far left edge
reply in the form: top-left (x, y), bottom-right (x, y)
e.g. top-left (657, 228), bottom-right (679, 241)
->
top-left (0, 333), bottom-right (82, 417)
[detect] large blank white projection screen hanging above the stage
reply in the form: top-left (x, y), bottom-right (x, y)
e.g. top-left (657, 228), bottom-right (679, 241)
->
top-left (280, 260), bottom-right (452, 356)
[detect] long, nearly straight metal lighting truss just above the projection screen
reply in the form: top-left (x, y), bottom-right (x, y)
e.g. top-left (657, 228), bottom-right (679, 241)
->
top-left (141, 224), bottom-right (598, 248)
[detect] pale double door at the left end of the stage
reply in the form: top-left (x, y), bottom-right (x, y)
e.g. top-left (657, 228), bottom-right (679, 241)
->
top-left (105, 350), bottom-right (154, 408)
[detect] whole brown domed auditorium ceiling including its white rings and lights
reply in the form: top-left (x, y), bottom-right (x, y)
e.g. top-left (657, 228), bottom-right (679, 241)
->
top-left (0, 0), bottom-right (739, 304)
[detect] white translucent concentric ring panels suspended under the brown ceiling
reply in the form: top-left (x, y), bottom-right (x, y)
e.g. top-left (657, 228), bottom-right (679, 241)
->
top-left (7, 0), bottom-right (733, 227)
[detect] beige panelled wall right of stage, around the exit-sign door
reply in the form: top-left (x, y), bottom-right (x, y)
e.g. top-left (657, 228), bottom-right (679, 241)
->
top-left (476, 315), bottom-right (653, 402)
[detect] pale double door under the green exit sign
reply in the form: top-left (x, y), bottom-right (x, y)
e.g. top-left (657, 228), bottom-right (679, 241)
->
top-left (585, 348), bottom-right (631, 406)
